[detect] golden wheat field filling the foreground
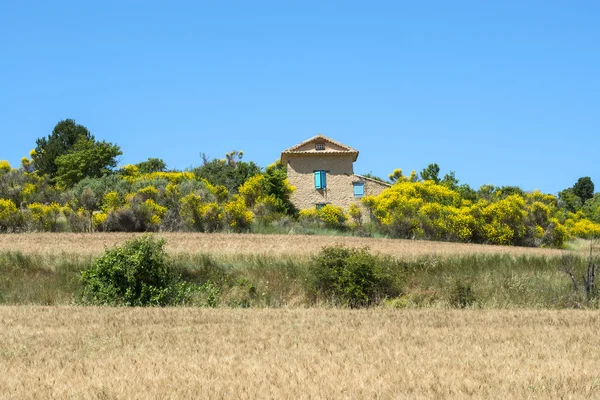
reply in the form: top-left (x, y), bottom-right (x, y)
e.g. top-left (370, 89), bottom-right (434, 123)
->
top-left (0, 306), bottom-right (600, 399)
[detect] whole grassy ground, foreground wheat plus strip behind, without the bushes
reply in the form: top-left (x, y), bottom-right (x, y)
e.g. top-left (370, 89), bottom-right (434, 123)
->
top-left (0, 233), bottom-right (600, 399)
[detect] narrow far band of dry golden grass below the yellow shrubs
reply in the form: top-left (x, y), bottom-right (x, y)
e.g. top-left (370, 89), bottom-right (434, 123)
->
top-left (0, 233), bottom-right (564, 258)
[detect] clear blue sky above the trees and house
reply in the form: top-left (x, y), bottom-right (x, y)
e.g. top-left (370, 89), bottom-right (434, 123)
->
top-left (0, 0), bottom-right (600, 193)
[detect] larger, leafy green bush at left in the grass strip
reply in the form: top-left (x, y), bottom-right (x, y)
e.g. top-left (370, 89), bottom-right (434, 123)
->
top-left (81, 235), bottom-right (194, 306)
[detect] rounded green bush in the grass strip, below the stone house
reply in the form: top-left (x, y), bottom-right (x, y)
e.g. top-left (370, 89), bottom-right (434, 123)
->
top-left (309, 246), bottom-right (400, 308)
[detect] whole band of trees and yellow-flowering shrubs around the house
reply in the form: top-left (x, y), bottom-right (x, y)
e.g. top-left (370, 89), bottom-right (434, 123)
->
top-left (0, 119), bottom-right (600, 247)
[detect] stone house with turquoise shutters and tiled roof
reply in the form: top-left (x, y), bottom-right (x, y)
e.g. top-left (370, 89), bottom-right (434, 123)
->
top-left (281, 134), bottom-right (390, 210)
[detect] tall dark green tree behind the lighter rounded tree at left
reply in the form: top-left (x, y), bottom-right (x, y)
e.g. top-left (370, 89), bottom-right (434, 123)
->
top-left (32, 119), bottom-right (94, 177)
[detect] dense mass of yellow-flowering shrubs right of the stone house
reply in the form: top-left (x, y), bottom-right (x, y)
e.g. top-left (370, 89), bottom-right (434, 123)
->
top-left (363, 180), bottom-right (568, 247)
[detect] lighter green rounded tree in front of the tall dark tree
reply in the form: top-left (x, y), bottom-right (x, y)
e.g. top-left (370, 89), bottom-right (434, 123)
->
top-left (55, 137), bottom-right (123, 187)
